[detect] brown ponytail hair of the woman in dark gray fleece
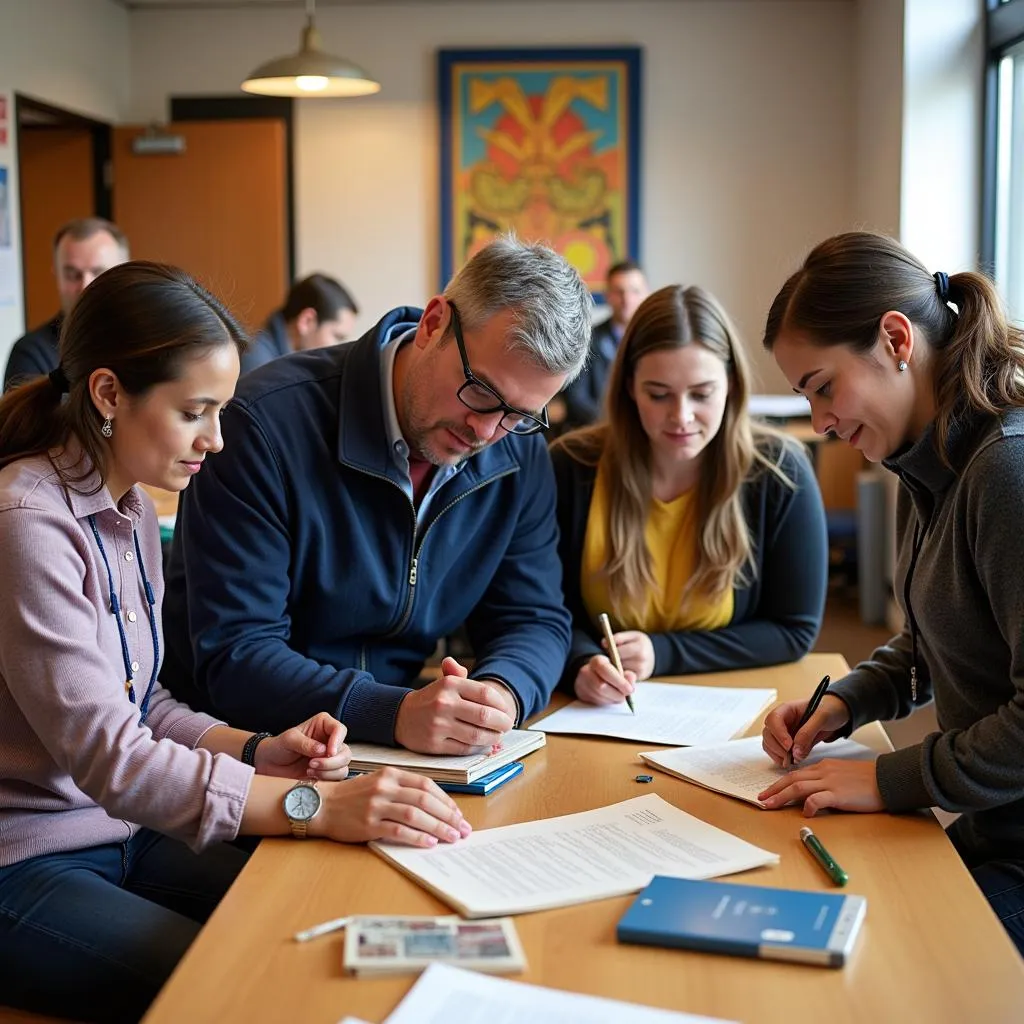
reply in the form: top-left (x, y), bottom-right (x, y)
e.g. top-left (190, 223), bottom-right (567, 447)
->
top-left (764, 231), bottom-right (1024, 458)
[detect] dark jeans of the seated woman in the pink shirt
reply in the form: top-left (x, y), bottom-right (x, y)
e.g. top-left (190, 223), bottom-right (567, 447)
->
top-left (0, 828), bottom-right (248, 1022)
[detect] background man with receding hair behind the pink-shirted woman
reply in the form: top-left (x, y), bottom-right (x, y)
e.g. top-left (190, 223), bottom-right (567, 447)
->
top-left (3, 217), bottom-right (129, 391)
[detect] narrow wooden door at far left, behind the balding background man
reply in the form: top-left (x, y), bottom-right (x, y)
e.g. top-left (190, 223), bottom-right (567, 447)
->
top-left (17, 126), bottom-right (96, 329)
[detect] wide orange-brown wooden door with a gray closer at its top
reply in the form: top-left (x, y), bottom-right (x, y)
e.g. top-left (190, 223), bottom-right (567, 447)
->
top-left (113, 119), bottom-right (289, 330)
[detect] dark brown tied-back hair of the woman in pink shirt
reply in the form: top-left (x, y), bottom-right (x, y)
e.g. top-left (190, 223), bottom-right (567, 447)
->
top-left (0, 261), bottom-right (248, 486)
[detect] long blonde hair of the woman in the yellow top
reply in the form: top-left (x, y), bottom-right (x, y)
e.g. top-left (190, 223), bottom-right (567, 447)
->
top-left (552, 285), bottom-right (794, 621)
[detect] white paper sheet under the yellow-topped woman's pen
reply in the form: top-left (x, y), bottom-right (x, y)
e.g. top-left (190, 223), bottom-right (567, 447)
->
top-left (534, 682), bottom-right (778, 746)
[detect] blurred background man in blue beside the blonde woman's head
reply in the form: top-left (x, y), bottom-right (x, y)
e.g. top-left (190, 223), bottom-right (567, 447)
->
top-left (559, 260), bottom-right (649, 432)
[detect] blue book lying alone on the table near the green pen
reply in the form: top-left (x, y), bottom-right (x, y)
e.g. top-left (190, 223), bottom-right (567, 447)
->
top-left (616, 874), bottom-right (867, 967)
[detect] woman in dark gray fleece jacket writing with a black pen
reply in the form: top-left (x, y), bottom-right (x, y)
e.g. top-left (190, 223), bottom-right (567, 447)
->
top-left (762, 232), bottom-right (1024, 952)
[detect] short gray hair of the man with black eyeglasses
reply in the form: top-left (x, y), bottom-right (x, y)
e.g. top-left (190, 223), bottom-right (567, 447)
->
top-left (444, 234), bottom-right (591, 384)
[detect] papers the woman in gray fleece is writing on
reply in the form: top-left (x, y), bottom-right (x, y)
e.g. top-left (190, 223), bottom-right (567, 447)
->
top-left (640, 736), bottom-right (879, 807)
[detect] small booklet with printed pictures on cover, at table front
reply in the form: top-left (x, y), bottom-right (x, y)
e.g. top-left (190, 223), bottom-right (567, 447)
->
top-left (344, 916), bottom-right (526, 977)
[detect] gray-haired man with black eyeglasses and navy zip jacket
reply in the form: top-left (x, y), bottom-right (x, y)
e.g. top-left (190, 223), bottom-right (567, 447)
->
top-left (161, 238), bottom-right (590, 754)
